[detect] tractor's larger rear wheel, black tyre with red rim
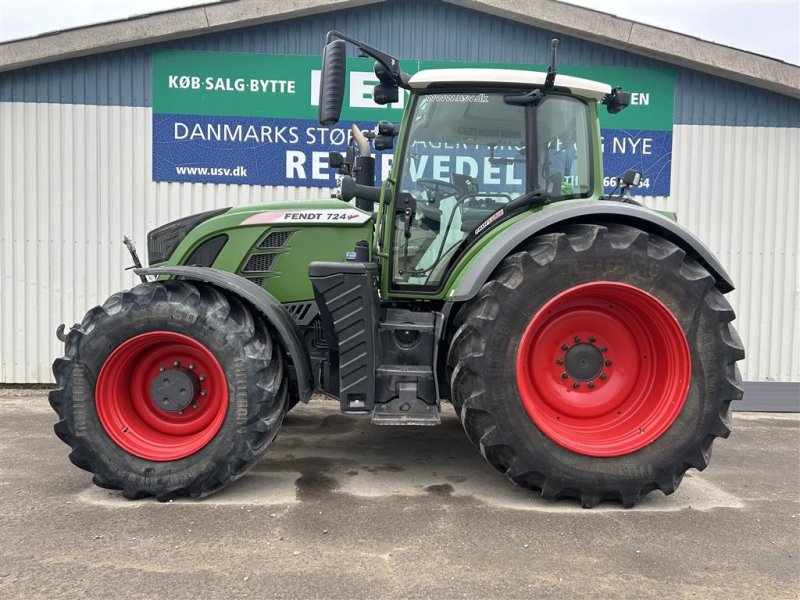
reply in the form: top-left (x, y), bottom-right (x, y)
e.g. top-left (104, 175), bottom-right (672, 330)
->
top-left (449, 225), bottom-right (744, 507)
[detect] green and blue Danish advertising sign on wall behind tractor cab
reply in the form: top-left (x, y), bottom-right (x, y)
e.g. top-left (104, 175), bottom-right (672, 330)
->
top-left (153, 50), bottom-right (675, 196)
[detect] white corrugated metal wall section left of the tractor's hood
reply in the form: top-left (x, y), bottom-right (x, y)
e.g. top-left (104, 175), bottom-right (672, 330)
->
top-left (0, 102), bottom-right (325, 383)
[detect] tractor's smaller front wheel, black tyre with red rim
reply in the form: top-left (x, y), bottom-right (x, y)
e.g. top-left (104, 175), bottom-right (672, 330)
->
top-left (50, 281), bottom-right (288, 501)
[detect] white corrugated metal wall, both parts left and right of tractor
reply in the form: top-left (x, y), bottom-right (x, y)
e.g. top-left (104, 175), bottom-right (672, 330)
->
top-left (0, 102), bottom-right (800, 382)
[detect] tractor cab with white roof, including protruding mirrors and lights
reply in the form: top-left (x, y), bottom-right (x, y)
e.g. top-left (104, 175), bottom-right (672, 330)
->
top-left (320, 32), bottom-right (627, 297)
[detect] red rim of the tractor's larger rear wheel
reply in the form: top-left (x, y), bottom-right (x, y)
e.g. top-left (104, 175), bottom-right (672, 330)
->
top-left (517, 281), bottom-right (692, 457)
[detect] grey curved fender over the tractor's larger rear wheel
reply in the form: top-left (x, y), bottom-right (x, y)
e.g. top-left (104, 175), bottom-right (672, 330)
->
top-left (446, 200), bottom-right (734, 302)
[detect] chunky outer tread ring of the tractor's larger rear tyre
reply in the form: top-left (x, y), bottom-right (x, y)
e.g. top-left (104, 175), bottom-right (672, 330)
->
top-left (447, 224), bottom-right (744, 507)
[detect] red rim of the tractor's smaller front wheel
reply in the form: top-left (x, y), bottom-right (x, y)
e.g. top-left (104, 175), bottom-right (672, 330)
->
top-left (95, 331), bottom-right (228, 461)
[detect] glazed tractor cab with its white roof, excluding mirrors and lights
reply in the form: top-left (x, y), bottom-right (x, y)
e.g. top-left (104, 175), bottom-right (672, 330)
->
top-left (384, 69), bottom-right (608, 292)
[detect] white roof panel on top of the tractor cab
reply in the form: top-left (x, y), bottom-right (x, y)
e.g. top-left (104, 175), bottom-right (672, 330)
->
top-left (408, 68), bottom-right (611, 100)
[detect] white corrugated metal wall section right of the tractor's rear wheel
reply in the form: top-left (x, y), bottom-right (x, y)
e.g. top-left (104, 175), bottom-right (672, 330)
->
top-left (646, 125), bottom-right (800, 381)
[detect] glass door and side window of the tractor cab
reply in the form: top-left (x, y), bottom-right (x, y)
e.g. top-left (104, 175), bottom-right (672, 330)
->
top-left (393, 91), bottom-right (592, 287)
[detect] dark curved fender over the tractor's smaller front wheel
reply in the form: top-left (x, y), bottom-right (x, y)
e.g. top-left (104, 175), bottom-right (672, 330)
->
top-left (133, 267), bottom-right (314, 402)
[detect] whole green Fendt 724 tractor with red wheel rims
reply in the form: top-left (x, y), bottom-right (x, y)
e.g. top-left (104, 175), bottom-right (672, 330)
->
top-left (50, 31), bottom-right (744, 507)
